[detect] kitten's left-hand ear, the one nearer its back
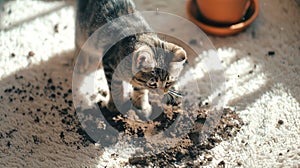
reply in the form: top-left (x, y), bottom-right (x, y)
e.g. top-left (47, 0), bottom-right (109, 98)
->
top-left (132, 46), bottom-right (155, 72)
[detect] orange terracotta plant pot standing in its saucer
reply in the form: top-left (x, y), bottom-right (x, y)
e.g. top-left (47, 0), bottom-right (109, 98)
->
top-left (197, 0), bottom-right (251, 24)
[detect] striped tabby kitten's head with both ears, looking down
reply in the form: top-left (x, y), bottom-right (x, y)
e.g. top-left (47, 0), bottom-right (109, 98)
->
top-left (131, 37), bottom-right (187, 95)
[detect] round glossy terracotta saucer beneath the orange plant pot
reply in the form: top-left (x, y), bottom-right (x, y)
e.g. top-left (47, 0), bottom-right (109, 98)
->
top-left (186, 0), bottom-right (259, 36)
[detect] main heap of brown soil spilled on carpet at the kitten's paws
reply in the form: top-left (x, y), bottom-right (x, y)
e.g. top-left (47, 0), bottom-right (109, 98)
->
top-left (76, 92), bottom-right (243, 167)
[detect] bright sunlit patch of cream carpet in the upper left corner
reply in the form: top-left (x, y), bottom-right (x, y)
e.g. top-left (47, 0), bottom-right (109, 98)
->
top-left (0, 2), bottom-right (75, 79)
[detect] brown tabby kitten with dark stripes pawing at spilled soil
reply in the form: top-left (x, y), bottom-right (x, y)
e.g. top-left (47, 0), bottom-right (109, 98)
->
top-left (76, 0), bottom-right (187, 120)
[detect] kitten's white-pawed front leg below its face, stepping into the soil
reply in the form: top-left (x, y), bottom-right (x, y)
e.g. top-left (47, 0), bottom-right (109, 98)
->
top-left (132, 88), bottom-right (152, 120)
